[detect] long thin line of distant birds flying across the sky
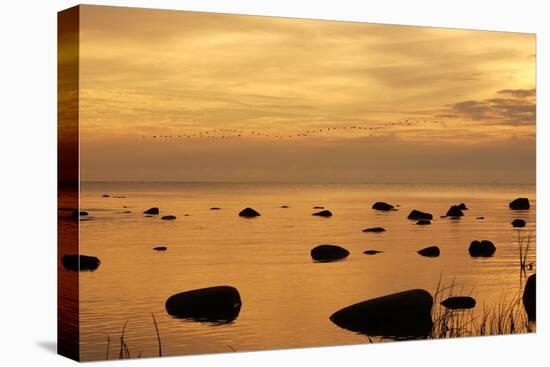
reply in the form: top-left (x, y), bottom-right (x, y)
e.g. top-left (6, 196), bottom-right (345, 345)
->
top-left (141, 120), bottom-right (442, 140)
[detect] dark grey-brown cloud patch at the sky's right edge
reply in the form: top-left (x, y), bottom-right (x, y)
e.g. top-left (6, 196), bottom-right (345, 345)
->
top-left (443, 89), bottom-right (536, 125)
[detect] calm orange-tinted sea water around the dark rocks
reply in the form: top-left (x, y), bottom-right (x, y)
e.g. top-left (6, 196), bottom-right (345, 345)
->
top-left (72, 183), bottom-right (536, 360)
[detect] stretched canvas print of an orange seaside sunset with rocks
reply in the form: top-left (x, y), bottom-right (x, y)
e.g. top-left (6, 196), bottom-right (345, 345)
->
top-left (58, 5), bottom-right (536, 361)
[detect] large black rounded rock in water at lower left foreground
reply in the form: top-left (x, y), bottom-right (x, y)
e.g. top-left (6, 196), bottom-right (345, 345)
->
top-left (165, 286), bottom-right (242, 322)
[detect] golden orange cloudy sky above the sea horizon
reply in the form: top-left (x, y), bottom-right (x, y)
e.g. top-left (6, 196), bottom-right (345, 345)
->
top-left (75, 6), bottom-right (536, 183)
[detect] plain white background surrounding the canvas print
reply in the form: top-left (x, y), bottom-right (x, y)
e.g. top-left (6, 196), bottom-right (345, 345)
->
top-left (0, 0), bottom-right (550, 366)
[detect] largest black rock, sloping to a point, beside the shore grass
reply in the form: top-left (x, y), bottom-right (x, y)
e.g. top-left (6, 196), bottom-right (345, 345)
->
top-left (330, 289), bottom-right (433, 338)
